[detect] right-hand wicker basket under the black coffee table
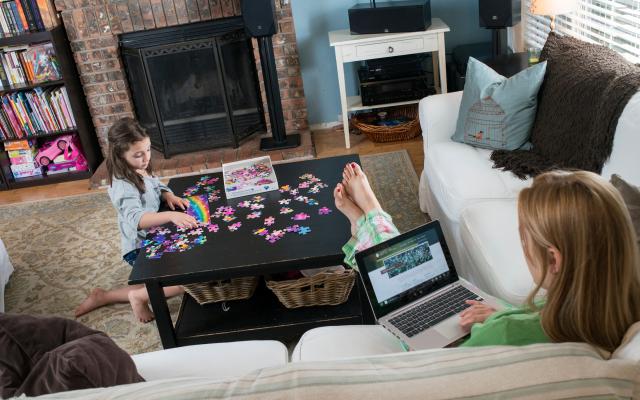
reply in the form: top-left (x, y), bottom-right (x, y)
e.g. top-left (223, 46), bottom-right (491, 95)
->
top-left (265, 269), bottom-right (356, 308)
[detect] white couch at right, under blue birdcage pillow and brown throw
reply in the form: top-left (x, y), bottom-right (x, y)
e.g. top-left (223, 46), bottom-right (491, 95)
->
top-left (419, 92), bottom-right (640, 304)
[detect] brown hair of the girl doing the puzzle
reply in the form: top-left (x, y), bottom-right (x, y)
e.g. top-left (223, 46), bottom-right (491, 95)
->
top-left (107, 118), bottom-right (153, 193)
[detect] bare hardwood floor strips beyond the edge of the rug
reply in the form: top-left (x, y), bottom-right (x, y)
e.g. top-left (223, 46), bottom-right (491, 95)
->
top-left (0, 126), bottom-right (424, 205)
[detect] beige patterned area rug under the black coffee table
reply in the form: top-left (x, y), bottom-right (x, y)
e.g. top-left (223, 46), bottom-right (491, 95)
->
top-left (0, 150), bottom-right (428, 354)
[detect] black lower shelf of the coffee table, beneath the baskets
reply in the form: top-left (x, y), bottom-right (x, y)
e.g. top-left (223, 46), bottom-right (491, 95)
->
top-left (175, 282), bottom-right (368, 346)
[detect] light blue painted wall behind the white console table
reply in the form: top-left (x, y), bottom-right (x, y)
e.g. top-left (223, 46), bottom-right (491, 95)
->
top-left (290, 0), bottom-right (491, 125)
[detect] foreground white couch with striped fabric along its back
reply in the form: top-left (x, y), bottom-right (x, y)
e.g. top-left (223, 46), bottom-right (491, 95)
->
top-left (27, 323), bottom-right (640, 400)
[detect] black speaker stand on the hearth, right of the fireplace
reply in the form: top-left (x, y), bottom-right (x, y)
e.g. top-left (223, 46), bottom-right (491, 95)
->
top-left (256, 36), bottom-right (300, 151)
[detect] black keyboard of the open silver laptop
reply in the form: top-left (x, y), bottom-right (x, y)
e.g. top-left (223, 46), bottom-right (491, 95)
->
top-left (389, 286), bottom-right (483, 337)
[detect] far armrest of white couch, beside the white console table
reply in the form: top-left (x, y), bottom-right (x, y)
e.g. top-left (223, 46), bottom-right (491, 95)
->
top-left (419, 92), bottom-right (462, 154)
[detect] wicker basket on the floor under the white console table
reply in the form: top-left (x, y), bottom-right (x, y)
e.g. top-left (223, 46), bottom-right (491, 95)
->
top-left (351, 104), bottom-right (422, 142)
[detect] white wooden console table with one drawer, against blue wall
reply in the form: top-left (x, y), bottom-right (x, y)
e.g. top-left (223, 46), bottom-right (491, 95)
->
top-left (329, 18), bottom-right (450, 148)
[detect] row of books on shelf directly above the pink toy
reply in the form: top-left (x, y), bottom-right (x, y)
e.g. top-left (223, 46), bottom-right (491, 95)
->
top-left (0, 86), bottom-right (76, 140)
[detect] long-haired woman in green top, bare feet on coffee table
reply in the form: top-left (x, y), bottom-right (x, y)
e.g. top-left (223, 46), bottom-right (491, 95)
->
top-left (334, 164), bottom-right (640, 351)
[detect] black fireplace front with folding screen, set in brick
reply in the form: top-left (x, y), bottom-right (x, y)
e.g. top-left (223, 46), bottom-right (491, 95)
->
top-left (120, 17), bottom-right (265, 158)
